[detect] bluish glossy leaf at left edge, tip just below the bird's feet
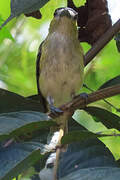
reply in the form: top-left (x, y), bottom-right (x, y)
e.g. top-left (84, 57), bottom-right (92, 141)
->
top-left (0, 111), bottom-right (55, 140)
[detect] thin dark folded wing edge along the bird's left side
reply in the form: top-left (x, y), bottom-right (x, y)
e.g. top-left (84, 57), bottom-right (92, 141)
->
top-left (36, 41), bottom-right (48, 112)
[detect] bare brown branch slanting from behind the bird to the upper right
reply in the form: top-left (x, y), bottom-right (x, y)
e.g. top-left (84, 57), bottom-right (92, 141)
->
top-left (85, 19), bottom-right (120, 66)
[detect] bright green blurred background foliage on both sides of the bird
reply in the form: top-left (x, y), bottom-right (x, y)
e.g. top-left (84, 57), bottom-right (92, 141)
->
top-left (0, 0), bottom-right (120, 176)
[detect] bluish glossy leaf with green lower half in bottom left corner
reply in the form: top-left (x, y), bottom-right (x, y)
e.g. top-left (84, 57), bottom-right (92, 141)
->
top-left (0, 142), bottom-right (45, 180)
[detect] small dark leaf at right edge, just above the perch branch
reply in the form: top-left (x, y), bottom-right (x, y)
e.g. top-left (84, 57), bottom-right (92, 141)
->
top-left (99, 76), bottom-right (120, 89)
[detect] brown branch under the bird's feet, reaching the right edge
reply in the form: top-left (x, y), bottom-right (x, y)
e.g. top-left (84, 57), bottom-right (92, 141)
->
top-left (48, 84), bottom-right (120, 117)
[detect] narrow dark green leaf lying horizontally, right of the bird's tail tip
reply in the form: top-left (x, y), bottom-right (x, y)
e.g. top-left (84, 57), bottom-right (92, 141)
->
top-left (61, 130), bottom-right (109, 144)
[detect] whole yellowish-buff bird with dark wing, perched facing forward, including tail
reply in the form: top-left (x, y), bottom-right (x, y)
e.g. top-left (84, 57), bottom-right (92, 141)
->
top-left (36, 7), bottom-right (84, 153)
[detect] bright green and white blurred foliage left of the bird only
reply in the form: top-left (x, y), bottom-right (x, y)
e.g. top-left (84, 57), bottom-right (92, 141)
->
top-left (0, 0), bottom-right (67, 96)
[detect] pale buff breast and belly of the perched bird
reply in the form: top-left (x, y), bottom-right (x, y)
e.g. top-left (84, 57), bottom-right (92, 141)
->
top-left (40, 34), bottom-right (83, 106)
